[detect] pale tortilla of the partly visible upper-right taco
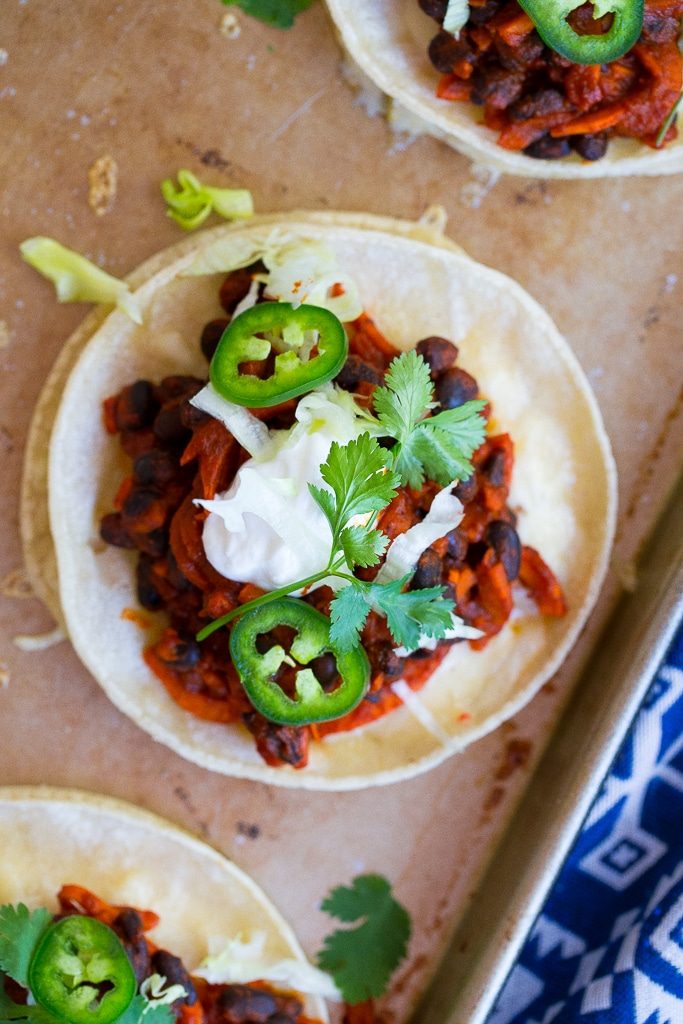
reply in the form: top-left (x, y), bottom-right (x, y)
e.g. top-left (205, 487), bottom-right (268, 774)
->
top-left (327, 0), bottom-right (683, 178)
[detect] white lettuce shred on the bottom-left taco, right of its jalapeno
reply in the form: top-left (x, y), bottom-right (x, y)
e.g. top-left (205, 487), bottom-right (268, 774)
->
top-left (193, 931), bottom-right (342, 1001)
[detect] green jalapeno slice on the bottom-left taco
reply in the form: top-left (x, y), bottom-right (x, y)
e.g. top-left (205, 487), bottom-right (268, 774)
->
top-left (29, 915), bottom-right (136, 1024)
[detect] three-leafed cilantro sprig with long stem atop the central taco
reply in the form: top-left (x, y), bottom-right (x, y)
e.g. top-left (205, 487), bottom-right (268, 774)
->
top-left (197, 351), bottom-right (485, 653)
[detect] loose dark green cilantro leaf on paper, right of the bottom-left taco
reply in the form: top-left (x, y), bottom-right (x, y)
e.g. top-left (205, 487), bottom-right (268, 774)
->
top-left (317, 874), bottom-right (411, 1004)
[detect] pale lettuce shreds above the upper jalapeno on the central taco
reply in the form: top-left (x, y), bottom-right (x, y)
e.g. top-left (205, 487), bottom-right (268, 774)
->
top-left (183, 228), bottom-right (362, 324)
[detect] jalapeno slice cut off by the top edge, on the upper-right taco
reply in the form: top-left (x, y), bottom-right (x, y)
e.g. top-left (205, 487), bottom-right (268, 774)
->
top-left (519, 0), bottom-right (643, 65)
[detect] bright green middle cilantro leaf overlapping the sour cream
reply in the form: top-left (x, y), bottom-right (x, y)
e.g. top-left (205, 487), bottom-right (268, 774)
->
top-left (308, 433), bottom-right (398, 564)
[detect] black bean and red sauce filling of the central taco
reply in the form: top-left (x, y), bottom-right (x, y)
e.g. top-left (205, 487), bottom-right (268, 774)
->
top-left (100, 265), bottom-right (566, 768)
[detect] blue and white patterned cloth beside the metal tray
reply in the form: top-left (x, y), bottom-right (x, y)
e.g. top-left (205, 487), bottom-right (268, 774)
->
top-left (487, 626), bottom-right (683, 1024)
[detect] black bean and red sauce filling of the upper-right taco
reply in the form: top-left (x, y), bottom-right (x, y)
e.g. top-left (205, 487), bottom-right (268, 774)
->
top-left (418, 0), bottom-right (683, 161)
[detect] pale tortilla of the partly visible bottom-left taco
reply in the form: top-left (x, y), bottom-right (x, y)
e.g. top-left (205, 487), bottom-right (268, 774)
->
top-left (0, 786), bottom-right (328, 1021)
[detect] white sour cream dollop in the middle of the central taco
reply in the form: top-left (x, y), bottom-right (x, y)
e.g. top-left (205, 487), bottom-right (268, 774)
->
top-left (197, 385), bottom-right (376, 590)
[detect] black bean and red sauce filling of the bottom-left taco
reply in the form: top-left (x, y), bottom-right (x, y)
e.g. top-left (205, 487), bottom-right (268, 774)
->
top-left (7, 885), bottom-right (316, 1024)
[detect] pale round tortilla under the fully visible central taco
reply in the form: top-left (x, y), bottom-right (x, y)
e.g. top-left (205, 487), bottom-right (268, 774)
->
top-left (23, 214), bottom-right (616, 790)
